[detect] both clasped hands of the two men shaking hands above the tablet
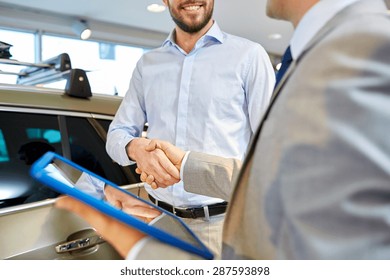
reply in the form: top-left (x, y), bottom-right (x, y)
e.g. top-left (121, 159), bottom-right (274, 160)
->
top-left (126, 138), bottom-right (186, 189)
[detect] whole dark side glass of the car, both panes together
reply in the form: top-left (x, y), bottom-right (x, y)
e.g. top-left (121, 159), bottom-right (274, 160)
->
top-left (0, 111), bottom-right (139, 208)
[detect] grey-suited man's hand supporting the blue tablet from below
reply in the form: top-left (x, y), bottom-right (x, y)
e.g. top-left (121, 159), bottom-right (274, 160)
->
top-left (55, 196), bottom-right (145, 258)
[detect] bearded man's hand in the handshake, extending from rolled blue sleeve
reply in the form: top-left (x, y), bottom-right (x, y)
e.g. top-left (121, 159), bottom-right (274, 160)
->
top-left (126, 138), bottom-right (180, 187)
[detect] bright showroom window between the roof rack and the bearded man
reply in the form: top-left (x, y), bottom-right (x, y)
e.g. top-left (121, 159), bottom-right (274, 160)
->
top-left (42, 35), bottom-right (145, 96)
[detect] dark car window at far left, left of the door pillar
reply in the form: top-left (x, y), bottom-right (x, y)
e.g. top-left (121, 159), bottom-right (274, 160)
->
top-left (0, 112), bottom-right (62, 207)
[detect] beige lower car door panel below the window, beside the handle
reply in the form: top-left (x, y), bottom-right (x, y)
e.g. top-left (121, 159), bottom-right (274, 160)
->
top-left (0, 199), bottom-right (119, 259)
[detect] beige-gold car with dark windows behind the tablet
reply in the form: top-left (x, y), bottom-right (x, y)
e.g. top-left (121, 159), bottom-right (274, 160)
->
top-left (0, 84), bottom-right (142, 260)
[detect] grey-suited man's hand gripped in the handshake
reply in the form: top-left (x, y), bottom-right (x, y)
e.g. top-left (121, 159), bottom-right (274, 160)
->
top-left (136, 139), bottom-right (185, 189)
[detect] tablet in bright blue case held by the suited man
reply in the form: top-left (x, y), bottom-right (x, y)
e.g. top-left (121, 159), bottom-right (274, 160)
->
top-left (30, 152), bottom-right (213, 259)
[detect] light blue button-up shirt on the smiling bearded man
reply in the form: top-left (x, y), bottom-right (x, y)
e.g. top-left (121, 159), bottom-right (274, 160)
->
top-left (106, 22), bottom-right (275, 206)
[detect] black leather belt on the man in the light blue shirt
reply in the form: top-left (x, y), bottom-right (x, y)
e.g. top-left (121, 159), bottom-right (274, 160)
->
top-left (149, 195), bottom-right (227, 219)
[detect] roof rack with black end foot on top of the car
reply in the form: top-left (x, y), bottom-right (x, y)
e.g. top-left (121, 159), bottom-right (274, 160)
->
top-left (0, 53), bottom-right (92, 98)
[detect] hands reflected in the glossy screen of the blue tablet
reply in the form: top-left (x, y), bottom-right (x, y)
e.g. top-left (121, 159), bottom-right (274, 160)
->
top-left (104, 185), bottom-right (161, 222)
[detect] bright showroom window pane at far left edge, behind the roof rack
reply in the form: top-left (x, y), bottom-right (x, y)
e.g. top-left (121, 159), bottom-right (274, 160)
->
top-left (0, 29), bottom-right (34, 84)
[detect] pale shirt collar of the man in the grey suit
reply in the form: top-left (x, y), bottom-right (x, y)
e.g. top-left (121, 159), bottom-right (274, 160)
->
top-left (290, 0), bottom-right (362, 60)
